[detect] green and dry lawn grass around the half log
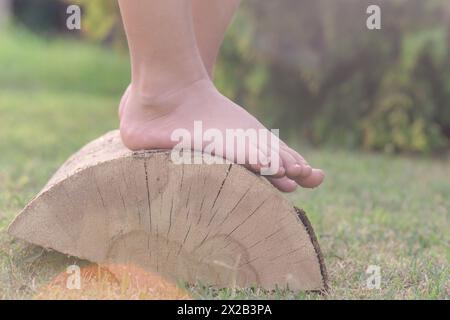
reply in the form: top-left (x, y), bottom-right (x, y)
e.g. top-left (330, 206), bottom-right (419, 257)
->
top-left (0, 30), bottom-right (450, 299)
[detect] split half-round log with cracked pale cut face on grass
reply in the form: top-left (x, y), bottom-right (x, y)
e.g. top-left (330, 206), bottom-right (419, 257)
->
top-left (9, 131), bottom-right (327, 291)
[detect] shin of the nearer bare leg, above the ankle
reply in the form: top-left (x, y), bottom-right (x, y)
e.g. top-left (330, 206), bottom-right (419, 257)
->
top-left (119, 0), bottom-right (207, 100)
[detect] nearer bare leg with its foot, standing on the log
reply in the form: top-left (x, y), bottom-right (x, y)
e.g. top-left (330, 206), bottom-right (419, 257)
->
top-left (119, 0), bottom-right (323, 191)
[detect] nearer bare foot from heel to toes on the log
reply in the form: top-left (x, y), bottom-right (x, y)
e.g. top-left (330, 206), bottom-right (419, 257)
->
top-left (119, 79), bottom-right (324, 192)
